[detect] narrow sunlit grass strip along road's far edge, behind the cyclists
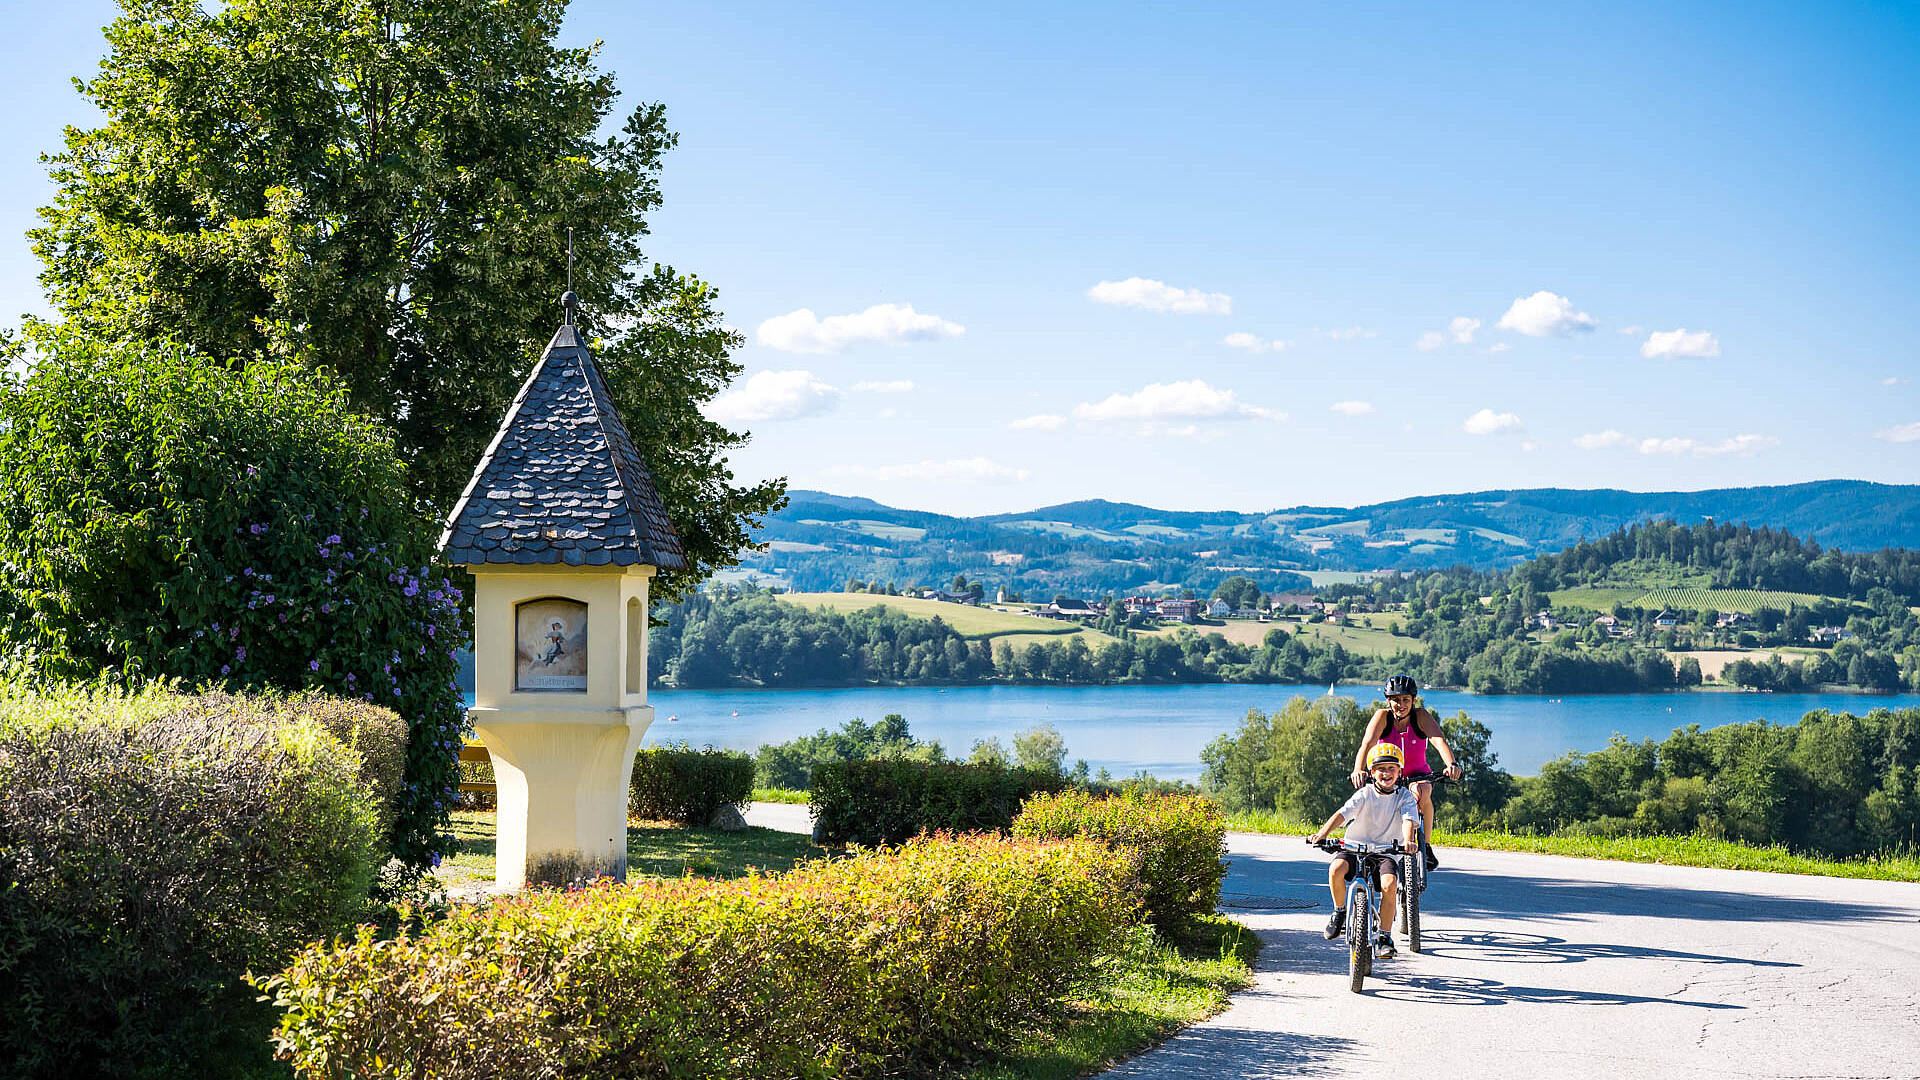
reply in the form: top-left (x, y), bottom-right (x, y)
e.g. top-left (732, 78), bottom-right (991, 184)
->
top-left (1227, 811), bottom-right (1920, 882)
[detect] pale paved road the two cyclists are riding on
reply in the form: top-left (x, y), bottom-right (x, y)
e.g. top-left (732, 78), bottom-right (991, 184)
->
top-left (1106, 832), bottom-right (1920, 1080)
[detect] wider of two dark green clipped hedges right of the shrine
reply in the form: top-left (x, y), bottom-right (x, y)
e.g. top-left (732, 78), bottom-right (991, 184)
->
top-left (808, 759), bottom-right (1066, 846)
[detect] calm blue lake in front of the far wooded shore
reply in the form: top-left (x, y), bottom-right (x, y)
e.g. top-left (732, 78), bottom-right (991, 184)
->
top-left (460, 684), bottom-right (1920, 778)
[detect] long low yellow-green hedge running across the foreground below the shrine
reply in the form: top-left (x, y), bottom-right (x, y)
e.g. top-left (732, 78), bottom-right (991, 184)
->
top-left (261, 836), bottom-right (1139, 1080)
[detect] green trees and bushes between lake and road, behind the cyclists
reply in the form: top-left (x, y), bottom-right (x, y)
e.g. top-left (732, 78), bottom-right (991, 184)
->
top-left (1202, 698), bottom-right (1920, 868)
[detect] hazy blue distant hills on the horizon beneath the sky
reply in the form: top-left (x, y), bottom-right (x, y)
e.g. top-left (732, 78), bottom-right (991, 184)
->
top-left (730, 480), bottom-right (1920, 598)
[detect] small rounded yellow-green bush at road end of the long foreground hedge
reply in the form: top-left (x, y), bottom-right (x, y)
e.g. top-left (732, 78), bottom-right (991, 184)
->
top-left (1014, 790), bottom-right (1227, 934)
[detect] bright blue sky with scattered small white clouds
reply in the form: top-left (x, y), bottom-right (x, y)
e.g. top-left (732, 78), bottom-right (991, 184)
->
top-left (0, 0), bottom-right (1920, 515)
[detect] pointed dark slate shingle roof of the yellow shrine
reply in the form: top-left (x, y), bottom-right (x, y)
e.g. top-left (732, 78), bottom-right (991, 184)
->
top-left (440, 321), bottom-right (685, 569)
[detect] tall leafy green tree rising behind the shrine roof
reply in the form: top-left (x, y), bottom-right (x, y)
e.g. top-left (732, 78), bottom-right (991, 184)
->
top-left (31, 0), bottom-right (785, 598)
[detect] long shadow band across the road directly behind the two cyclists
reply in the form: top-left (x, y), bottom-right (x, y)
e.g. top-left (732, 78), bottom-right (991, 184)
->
top-left (1227, 853), bottom-right (1914, 922)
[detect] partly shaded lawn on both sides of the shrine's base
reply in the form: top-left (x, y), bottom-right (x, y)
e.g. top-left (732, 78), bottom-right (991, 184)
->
top-left (436, 811), bottom-right (826, 886)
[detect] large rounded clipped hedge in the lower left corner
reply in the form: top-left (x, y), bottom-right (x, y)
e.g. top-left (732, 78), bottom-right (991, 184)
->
top-left (0, 688), bottom-right (385, 1078)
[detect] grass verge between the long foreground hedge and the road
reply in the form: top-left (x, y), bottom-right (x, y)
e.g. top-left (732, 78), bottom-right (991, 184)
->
top-left (968, 915), bottom-right (1260, 1080)
